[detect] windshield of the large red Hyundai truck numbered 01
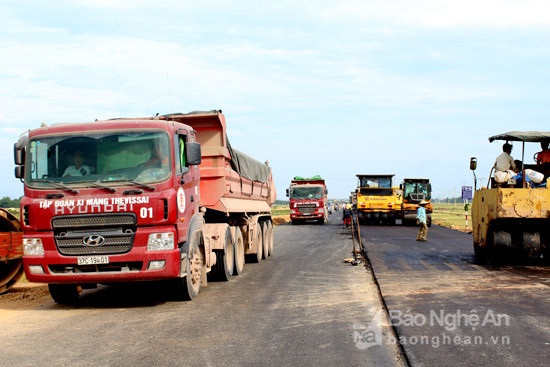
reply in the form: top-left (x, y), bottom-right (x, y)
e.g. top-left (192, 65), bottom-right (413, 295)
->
top-left (25, 130), bottom-right (171, 188)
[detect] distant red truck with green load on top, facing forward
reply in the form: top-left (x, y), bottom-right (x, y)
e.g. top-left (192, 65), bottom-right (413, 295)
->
top-left (286, 176), bottom-right (328, 224)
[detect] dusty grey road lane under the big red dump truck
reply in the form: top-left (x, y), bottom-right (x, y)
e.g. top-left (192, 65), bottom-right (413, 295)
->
top-left (0, 215), bottom-right (404, 367)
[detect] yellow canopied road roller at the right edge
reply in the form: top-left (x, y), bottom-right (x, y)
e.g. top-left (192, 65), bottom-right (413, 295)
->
top-left (470, 131), bottom-right (550, 264)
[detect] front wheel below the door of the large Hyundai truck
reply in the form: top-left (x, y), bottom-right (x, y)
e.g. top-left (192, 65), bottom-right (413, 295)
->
top-left (176, 230), bottom-right (204, 301)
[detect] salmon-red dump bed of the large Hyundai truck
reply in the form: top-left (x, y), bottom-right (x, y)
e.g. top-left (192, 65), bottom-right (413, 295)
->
top-left (159, 111), bottom-right (276, 213)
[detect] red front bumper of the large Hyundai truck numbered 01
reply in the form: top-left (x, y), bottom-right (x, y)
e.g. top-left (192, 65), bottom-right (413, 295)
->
top-left (23, 227), bottom-right (181, 284)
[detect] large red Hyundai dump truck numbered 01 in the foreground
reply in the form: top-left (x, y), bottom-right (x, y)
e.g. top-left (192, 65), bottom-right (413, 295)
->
top-left (14, 110), bottom-right (276, 304)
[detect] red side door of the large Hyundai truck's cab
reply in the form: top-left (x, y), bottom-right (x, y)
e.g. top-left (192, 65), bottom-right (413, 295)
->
top-left (172, 132), bottom-right (200, 243)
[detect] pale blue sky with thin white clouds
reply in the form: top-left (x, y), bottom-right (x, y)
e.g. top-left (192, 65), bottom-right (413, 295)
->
top-left (0, 0), bottom-right (550, 200)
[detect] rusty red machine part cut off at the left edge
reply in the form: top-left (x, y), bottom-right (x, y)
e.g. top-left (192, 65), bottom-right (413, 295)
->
top-left (0, 208), bottom-right (23, 294)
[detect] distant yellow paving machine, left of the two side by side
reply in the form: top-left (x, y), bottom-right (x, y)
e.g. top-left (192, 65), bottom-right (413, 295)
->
top-left (356, 175), bottom-right (401, 224)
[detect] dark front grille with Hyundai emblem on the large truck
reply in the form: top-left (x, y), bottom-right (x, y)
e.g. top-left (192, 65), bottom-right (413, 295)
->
top-left (52, 214), bottom-right (137, 256)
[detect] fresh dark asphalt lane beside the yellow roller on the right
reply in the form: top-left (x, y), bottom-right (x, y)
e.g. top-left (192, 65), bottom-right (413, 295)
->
top-left (361, 226), bottom-right (550, 366)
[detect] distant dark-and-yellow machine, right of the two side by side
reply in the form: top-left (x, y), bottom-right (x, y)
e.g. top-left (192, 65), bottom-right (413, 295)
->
top-left (400, 178), bottom-right (433, 226)
